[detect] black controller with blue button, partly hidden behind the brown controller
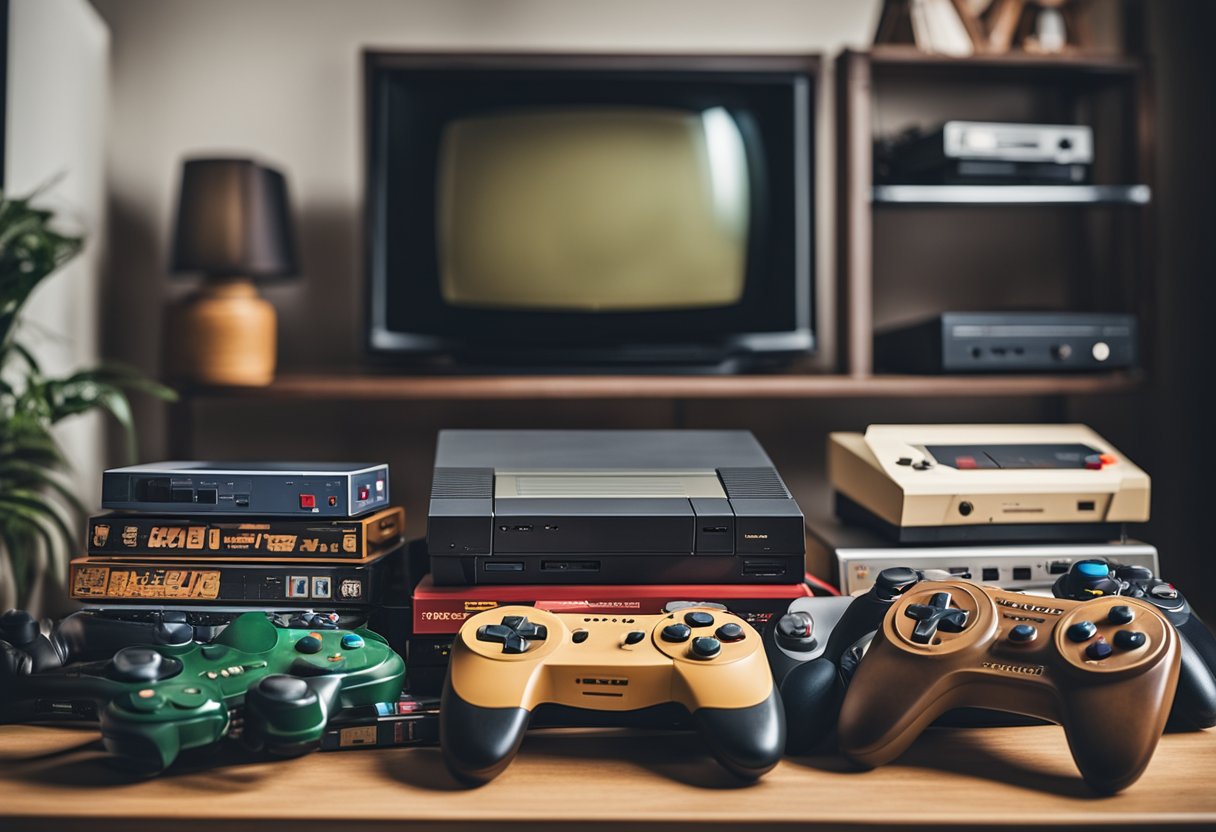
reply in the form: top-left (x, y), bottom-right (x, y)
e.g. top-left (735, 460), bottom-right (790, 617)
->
top-left (1052, 558), bottom-right (1216, 731)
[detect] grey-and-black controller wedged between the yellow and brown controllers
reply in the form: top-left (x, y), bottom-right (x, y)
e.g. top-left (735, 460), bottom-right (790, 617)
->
top-left (765, 567), bottom-right (922, 754)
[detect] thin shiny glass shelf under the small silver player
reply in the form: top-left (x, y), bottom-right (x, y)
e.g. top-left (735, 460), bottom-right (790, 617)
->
top-left (871, 185), bottom-right (1153, 206)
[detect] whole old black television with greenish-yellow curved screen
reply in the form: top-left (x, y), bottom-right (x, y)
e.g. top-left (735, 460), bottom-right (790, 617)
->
top-left (365, 52), bottom-right (818, 366)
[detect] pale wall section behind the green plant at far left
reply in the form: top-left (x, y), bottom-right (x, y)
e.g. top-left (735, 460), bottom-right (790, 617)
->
top-left (0, 0), bottom-right (109, 608)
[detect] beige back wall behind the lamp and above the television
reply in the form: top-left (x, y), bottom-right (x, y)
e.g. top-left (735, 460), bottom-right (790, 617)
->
top-left (85, 0), bottom-right (878, 452)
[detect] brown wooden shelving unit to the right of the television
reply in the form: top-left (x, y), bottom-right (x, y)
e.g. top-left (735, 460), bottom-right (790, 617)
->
top-left (835, 46), bottom-right (1156, 377)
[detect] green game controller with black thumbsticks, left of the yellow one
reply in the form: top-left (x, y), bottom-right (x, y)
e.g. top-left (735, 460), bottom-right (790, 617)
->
top-left (0, 612), bottom-right (405, 774)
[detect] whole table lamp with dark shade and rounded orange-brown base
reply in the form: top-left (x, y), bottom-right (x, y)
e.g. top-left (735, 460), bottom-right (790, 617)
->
top-left (165, 158), bottom-right (297, 387)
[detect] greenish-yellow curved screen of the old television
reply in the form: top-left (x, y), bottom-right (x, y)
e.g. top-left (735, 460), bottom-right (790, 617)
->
top-left (435, 107), bottom-right (749, 313)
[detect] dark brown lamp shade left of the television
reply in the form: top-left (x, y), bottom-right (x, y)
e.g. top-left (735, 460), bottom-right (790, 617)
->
top-left (173, 159), bottom-right (297, 277)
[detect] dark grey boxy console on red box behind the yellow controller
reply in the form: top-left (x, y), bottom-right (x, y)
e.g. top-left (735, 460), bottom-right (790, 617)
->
top-left (427, 431), bottom-right (806, 586)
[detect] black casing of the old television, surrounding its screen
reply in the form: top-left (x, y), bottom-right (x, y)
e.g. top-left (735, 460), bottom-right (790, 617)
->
top-left (364, 51), bottom-right (820, 372)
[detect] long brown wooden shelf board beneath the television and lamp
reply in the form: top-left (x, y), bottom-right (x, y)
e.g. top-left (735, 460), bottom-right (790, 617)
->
top-left (184, 372), bottom-right (1142, 401)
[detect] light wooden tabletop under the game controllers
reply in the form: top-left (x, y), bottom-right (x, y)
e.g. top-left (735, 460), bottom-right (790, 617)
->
top-left (0, 725), bottom-right (1216, 832)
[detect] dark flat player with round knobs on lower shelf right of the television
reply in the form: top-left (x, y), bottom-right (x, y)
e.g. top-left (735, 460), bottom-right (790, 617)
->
top-left (874, 311), bottom-right (1137, 373)
